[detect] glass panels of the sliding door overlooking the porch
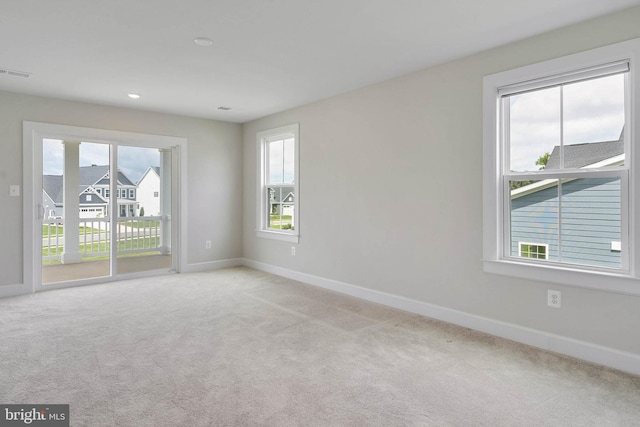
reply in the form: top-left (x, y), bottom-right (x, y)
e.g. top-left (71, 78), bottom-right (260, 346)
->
top-left (34, 138), bottom-right (177, 287)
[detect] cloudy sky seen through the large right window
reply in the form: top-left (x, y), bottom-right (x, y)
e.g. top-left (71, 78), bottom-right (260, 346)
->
top-left (510, 74), bottom-right (624, 172)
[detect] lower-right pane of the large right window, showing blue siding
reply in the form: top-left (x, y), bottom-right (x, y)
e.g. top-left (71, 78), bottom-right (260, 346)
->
top-left (560, 178), bottom-right (622, 268)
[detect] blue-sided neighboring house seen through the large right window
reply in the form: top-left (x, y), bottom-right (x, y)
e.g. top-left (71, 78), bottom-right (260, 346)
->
top-left (511, 135), bottom-right (624, 268)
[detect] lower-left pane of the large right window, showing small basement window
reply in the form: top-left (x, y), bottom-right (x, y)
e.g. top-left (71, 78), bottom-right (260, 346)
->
top-left (509, 179), bottom-right (558, 261)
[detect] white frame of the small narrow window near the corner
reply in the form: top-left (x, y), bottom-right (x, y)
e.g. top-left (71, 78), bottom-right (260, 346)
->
top-left (256, 123), bottom-right (300, 243)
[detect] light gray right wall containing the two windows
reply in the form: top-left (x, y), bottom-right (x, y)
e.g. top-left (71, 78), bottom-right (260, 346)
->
top-left (243, 8), bottom-right (640, 354)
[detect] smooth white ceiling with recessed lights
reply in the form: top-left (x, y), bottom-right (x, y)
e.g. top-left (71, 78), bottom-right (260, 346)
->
top-left (0, 0), bottom-right (640, 122)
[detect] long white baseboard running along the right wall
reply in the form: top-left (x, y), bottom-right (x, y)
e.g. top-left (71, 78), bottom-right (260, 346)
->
top-left (242, 259), bottom-right (640, 375)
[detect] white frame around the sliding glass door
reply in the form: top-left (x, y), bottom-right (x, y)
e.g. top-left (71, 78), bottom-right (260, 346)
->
top-left (21, 121), bottom-right (187, 293)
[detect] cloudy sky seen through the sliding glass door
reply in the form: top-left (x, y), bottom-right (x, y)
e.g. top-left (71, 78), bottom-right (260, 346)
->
top-left (42, 139), bottom-right (160, 182)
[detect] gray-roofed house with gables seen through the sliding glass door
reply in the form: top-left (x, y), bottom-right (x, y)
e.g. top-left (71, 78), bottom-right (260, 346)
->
top-left (42, 165), bottom-right (138, 218)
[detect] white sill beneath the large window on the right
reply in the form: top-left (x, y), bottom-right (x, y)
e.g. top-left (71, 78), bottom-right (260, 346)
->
top-left (483, 260), bottom-right (640, 296)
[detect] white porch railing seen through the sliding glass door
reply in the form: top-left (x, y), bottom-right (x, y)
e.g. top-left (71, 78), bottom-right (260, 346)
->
top-left (42, 216), bottom-right (168, 262)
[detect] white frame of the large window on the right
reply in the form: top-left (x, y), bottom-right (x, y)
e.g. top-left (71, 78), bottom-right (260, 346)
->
top-left (483, 39), bottom-right (640, 295)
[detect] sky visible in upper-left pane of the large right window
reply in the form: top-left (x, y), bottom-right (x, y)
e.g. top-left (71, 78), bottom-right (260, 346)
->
top-left (507, 87), bottom-right (560, 172)
